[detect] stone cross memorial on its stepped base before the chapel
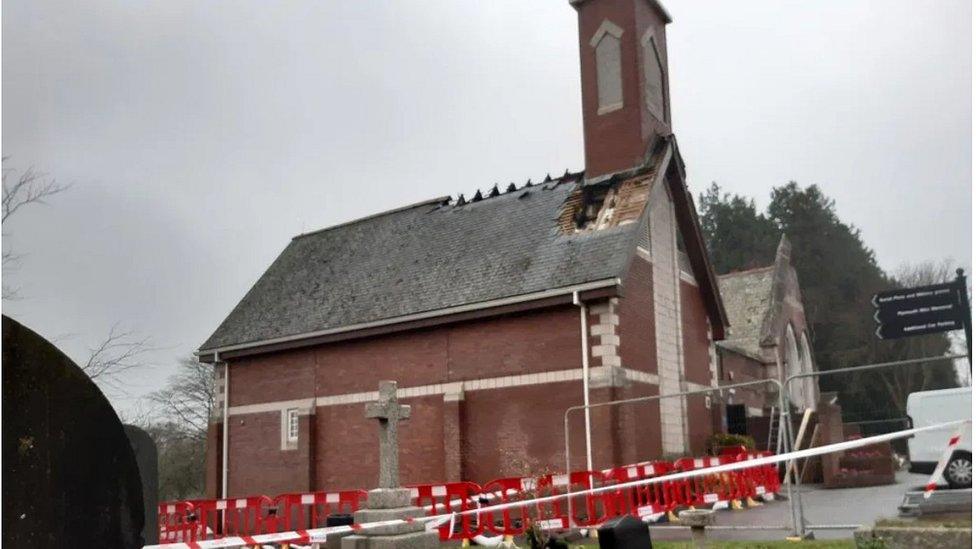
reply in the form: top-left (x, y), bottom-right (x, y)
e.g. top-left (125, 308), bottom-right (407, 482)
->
top-left (342, 381), bottom-right (440, 549)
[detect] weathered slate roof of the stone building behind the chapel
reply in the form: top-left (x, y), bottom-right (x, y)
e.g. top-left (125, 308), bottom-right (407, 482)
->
top-left (718, 265), bottom-right (775, 359)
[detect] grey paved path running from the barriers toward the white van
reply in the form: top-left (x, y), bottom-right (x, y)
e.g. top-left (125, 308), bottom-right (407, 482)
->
top-left (651, 471), bottom-right (927, 540)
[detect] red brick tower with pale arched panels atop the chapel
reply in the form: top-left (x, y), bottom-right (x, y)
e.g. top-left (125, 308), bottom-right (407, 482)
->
top-left (569, 0), bottom-right (671, 179)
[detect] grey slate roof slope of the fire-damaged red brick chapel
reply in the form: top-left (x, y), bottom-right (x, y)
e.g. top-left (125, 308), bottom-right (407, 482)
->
top-left (201, 174), bottom-right (640, 351)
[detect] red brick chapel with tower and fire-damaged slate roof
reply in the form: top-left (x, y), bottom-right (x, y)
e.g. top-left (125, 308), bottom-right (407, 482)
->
top-left (198, 0), bottom-right (816, 497)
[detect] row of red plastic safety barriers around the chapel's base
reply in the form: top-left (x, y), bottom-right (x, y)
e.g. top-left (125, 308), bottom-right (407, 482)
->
top-left (158, 448), bottom-right (780, 543)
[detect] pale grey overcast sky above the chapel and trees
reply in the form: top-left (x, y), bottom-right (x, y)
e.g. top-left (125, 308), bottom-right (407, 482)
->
top-left (2, 0), bottom-right (972, 409)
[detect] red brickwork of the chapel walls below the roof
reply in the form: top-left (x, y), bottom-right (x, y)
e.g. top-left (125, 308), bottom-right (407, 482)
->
top-left (221, 276), bottom-right (720, 496)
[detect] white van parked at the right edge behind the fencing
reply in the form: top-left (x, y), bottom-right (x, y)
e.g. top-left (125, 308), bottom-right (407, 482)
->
top-left (908, 387), bottom-right (973, 488)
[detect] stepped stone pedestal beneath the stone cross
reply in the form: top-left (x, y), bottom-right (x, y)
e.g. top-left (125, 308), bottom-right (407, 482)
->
top-left (342, 488), bottom-right (440, 549)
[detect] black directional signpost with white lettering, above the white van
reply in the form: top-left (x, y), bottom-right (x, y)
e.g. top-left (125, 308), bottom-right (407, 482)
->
top-left (871, 269), bottom-right (973, 368)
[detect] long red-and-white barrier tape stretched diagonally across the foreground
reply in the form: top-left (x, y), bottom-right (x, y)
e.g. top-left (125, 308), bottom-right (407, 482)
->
top-left (144, 419), bottom-right (972, 549)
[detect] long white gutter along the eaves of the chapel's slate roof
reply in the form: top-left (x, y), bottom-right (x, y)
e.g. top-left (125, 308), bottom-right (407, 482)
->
top-left (196, 278), bottom-right (620, 356)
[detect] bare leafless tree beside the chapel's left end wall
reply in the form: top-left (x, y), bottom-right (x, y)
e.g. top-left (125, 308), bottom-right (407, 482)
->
top-left (148, 357), bottom-right (216, 440)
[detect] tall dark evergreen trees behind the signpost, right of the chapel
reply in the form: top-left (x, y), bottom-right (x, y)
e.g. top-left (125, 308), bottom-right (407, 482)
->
top-left (699, 181), bottom-right (958, 421)
